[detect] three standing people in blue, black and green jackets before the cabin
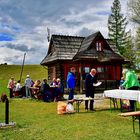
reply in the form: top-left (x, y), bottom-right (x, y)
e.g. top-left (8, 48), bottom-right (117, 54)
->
top-left (67, 67), bottom-right (140, 111)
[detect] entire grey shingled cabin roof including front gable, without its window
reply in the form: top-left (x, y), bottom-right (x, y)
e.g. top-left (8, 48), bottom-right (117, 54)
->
top-left (41, 32), bottom-right (124, 65)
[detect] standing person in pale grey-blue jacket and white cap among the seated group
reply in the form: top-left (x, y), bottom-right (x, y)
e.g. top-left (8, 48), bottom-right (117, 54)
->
top-left (25, 75), bottom-right (32, 97)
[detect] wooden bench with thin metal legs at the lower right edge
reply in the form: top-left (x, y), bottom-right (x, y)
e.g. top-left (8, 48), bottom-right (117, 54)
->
top-left (119, 111), bottom-right (140, 133)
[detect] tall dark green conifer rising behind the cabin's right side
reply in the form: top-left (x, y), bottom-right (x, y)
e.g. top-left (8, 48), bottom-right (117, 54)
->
top-left (108, 0), bottom-right (127, 55)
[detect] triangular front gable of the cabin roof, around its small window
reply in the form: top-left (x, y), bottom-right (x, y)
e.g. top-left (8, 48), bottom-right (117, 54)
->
top-left (73, 32), bottom-right (123, 62)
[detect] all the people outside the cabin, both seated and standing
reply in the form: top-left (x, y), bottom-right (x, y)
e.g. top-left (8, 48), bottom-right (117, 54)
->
top-left (7, 67), bottom-right (140, 111)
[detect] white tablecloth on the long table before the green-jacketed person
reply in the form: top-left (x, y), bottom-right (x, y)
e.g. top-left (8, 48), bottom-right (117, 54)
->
top-left (104, 89), bottom-right (140, 102)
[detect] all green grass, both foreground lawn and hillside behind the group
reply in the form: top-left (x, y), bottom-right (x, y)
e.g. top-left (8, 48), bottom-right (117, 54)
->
top-left (0, 65), bottom-right (140, 140)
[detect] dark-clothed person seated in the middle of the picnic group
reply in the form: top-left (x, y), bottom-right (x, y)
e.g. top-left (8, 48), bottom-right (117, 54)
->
top-left (40, 79), bottom-right (51, 102)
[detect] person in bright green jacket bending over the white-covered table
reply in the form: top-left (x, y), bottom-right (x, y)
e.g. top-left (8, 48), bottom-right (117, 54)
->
top-left (122, 69), bottom-right (140, 111)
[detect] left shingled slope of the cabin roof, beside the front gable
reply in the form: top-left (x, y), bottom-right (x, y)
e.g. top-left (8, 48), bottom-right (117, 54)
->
top-left (41, 35), bottom-right (84, 65)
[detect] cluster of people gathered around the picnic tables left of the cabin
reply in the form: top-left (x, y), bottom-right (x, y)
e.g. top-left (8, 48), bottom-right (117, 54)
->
top-left (7, 75), bottom-right (64, 101)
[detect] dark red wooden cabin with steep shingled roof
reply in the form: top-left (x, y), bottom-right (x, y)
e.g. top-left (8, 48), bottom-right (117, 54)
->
top-left (41, 32), bottom-right (124, 93)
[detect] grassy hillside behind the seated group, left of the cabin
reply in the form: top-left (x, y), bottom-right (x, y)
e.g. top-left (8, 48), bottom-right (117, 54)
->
top-left (0, 65), bottom-right (48, 95)
